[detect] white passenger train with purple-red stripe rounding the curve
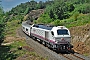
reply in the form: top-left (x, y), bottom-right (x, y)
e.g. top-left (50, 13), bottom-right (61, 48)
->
top-left (22, 21), bottom-right (73, 52)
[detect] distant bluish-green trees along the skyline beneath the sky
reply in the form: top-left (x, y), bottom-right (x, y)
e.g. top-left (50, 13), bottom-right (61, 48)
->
top-left (9, 1), bottom-right (52, 15)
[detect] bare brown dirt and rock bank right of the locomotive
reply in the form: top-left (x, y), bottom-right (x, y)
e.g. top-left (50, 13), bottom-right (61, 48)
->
top-left (70, 24), bottom-right (90, 56)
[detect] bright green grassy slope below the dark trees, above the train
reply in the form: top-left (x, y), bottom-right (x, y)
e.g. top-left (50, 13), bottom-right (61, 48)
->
top-left (34, 13), bottom-right (90, 27)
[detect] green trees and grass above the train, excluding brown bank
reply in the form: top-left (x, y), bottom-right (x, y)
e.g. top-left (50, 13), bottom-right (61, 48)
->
top-left (34, 0), bottom-right (90, 27)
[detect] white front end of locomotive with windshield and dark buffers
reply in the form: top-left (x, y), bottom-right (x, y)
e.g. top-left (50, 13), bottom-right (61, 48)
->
top-left (52, 26), bottom-right (72, 51)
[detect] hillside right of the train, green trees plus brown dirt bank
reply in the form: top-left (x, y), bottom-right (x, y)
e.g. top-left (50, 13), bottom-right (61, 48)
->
top-left (34, 0), bottom-right (90, 56)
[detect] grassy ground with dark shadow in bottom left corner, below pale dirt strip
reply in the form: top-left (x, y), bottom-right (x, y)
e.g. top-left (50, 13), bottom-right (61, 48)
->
top-left (0, 40), bottom-right (46, 60)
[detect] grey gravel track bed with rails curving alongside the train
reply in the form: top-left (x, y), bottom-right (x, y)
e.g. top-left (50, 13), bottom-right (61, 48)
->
top-left (18, 28), bottom-right (90, 60)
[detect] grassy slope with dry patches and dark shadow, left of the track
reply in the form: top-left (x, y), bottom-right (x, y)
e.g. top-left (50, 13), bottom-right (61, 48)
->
top-left (0, 20), bottom-right (46, 60)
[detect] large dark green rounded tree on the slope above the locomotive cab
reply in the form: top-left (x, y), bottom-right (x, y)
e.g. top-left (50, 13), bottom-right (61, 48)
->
top-left (46, 0), bottom-right (75, 20)
